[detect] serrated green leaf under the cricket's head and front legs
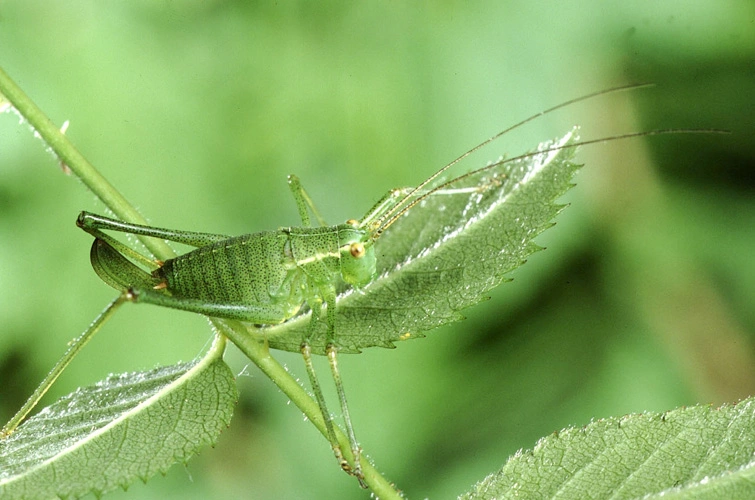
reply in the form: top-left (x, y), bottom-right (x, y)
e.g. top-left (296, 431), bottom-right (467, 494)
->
top-left (261, 131), bottom-right (579, 353)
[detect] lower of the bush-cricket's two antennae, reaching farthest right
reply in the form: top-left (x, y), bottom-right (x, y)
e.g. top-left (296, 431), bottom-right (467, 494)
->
top-left (373, 127), bottom-right (731, 236)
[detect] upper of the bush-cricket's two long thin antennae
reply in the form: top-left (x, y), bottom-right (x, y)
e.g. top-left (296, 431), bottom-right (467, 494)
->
top-left (373, 83), bottom-right (655, 240)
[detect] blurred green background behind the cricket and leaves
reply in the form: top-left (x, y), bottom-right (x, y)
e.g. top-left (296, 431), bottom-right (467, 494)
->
top-left (0, 0), bottom-right (755, 500)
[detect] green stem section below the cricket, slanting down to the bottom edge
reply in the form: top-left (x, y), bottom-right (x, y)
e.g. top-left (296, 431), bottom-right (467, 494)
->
top-left (212, 319), bottom-right (402, 500)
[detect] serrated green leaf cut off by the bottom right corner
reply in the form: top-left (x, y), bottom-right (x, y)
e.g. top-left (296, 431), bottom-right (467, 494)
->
top-left (460, 398), bottom-right (755, 500)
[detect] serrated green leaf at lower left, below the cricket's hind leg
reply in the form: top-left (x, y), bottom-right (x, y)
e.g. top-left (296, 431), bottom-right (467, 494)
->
top-left (0, 343), bottom-right (238, 500)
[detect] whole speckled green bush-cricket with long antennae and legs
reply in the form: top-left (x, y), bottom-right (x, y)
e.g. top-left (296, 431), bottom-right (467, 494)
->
top-left (0, 84), bottom-right (710, 488)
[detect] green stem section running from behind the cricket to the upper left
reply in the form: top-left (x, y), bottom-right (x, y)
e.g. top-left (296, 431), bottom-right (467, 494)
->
top-left (0, 68), bottom-right (175, 260)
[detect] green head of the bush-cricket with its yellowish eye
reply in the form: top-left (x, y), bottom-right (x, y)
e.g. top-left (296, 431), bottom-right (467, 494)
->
top-left (338, 221), bottom-right (377, 287)
